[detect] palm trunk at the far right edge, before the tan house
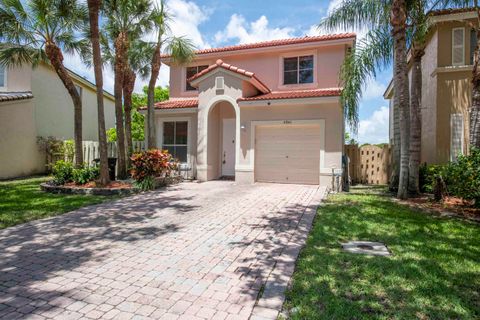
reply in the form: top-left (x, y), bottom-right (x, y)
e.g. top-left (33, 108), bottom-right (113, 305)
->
top-left (469, 19), bottom-right (480, 148)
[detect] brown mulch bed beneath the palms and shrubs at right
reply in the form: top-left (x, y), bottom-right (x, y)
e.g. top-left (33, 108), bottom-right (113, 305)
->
top-left (398, 194), bottom-right (480, 222)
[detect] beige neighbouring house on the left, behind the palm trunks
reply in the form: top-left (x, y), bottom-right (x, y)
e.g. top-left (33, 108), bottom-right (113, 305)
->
top-left (0, 64), bottom-right (115, 179)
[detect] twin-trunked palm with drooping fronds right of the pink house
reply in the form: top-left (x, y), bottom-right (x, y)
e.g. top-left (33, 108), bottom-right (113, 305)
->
top-left (320, 0), bottom-right (439, 196)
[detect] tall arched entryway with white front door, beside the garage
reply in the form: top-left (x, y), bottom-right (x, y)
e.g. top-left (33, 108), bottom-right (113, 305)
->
top-left (206, 100), bottom-right (237, 180)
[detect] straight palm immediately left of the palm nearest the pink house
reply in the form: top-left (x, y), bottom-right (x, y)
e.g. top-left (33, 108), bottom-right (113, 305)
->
top-left (104, 0), bottom-right (151, 179)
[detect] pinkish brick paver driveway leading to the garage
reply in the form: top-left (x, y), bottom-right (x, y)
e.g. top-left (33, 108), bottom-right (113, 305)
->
top-left (0, 181), bottom-right (324, 319)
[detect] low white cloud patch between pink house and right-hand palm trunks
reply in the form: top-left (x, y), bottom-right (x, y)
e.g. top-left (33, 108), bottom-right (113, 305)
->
top-left (357, 107), bottom-right (389, 144)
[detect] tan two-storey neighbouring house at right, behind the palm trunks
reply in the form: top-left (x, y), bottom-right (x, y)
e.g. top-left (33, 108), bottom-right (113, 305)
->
top-left (384, 9), bottom-right (477, 164)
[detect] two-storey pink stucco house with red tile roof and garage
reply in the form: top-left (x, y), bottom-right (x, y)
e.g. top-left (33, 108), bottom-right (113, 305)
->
top-left (155, 33), bottom-right (356, 185)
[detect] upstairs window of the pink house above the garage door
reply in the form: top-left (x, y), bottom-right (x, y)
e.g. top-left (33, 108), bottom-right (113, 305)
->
top-left (283, 55), bottom-right (313, 84)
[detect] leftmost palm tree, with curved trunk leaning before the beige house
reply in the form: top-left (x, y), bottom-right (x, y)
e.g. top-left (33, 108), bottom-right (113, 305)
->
top-left (0, 0), bottom-right (89, 166)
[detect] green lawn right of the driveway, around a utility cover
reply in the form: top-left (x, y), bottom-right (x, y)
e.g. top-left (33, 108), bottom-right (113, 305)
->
top-left (284, 189), bottom-right (480, 319)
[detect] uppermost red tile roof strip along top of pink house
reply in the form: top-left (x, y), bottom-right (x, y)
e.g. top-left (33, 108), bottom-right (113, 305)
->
top-left (162, 33), bottom-right (356, 58)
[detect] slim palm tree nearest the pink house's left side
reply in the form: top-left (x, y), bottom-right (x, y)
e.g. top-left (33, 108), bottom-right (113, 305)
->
top-left (147, 0), bottom-right (194, 148)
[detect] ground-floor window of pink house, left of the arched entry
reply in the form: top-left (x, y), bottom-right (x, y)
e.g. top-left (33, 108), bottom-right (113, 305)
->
top-left (162, 121), bottom-right (188, 162)
